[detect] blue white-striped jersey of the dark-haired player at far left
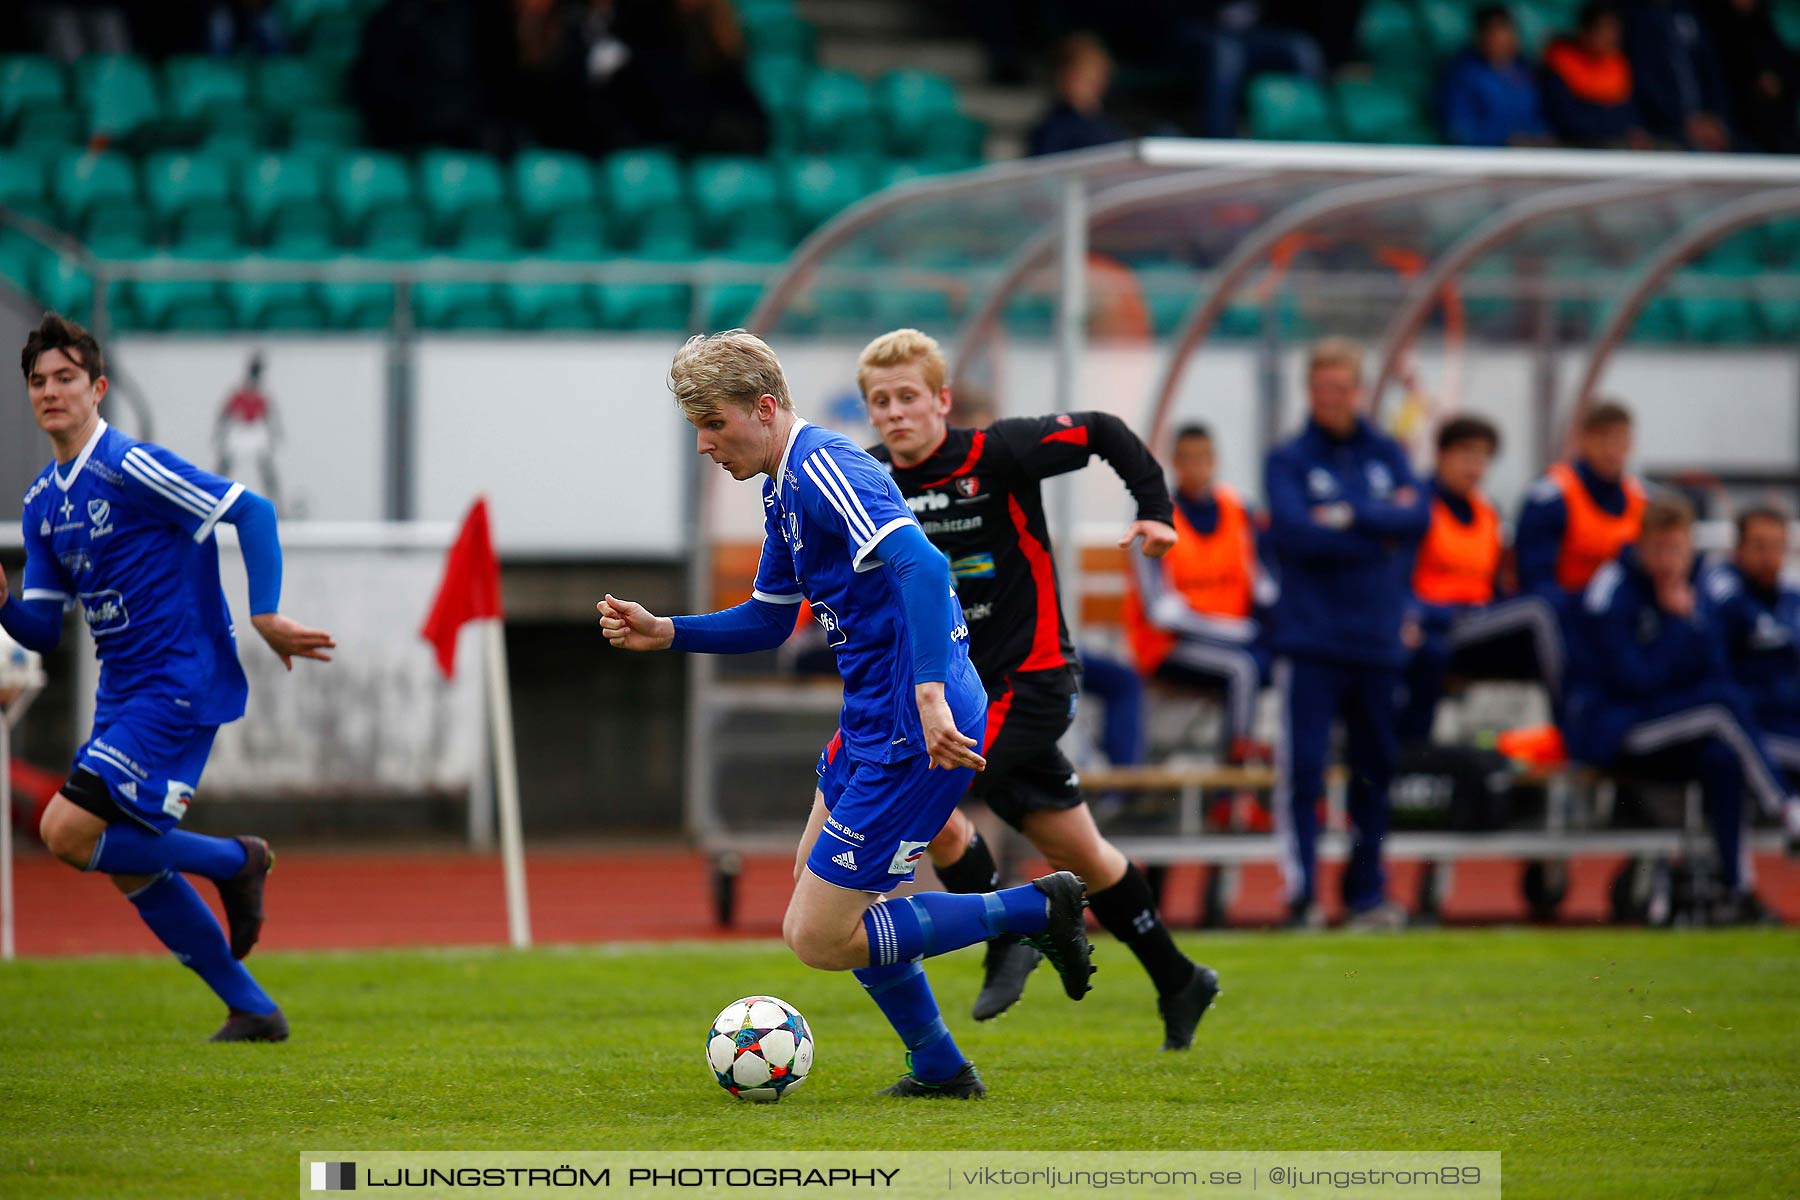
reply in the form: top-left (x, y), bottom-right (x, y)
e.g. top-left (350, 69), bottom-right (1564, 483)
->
top-left (20, 421), bottom-right (248, 725)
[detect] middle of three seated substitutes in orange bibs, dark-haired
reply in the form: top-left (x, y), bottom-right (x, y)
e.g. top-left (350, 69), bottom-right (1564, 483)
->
top-left (1400, 416), bottom-right (1562, 745)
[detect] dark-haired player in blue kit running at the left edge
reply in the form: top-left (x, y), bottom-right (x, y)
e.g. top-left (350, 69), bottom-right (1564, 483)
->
top-left (0, 313), bottom-right (333, 1042)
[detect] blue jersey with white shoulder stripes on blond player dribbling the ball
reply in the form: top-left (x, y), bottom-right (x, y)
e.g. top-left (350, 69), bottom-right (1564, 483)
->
top-left (756, 419), bottom-right (985, 763)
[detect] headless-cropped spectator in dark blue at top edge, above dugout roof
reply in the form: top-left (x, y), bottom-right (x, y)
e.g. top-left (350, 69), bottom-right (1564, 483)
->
top-left (1174, 0), bottom-right (1325, 137)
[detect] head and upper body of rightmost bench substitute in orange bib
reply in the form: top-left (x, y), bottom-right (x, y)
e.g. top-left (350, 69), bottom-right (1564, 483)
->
top-left (1512, 399), bottom-right (1645, 603)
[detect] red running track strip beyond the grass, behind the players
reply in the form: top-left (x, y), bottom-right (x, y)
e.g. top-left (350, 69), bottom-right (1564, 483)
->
top-left (16, 847), bottom-right (1800, 955)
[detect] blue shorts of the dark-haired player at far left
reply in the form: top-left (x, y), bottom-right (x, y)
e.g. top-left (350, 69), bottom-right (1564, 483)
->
top-left (76, 696), bottom-right (218, 833)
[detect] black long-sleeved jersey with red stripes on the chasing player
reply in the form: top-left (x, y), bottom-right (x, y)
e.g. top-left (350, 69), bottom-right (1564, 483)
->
top-left (869, 412), bottom-right (1174, 685)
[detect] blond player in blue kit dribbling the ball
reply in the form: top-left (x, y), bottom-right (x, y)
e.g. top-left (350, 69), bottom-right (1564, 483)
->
top-left (599, 329), bottom-right (1093, 1099)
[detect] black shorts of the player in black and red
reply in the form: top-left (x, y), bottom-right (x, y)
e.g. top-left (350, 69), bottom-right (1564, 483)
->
top-left (968, 671), bottom-right (1082, 829)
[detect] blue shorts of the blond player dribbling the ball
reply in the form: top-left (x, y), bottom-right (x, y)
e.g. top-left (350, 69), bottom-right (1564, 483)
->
top-left (806, 707), bottom-right (986, 892)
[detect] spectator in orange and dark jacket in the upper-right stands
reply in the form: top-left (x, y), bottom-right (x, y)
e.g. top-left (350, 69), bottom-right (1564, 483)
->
top-left (1539, 4), bottom-right (1654, 149)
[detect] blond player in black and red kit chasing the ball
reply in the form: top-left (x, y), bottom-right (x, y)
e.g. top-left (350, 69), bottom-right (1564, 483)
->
top-left (857, 329), bottom-right (1219, 1051)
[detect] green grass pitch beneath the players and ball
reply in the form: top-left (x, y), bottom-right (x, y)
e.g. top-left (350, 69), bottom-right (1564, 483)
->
top-left (0, 930), bottom-right (1800, 1200)
